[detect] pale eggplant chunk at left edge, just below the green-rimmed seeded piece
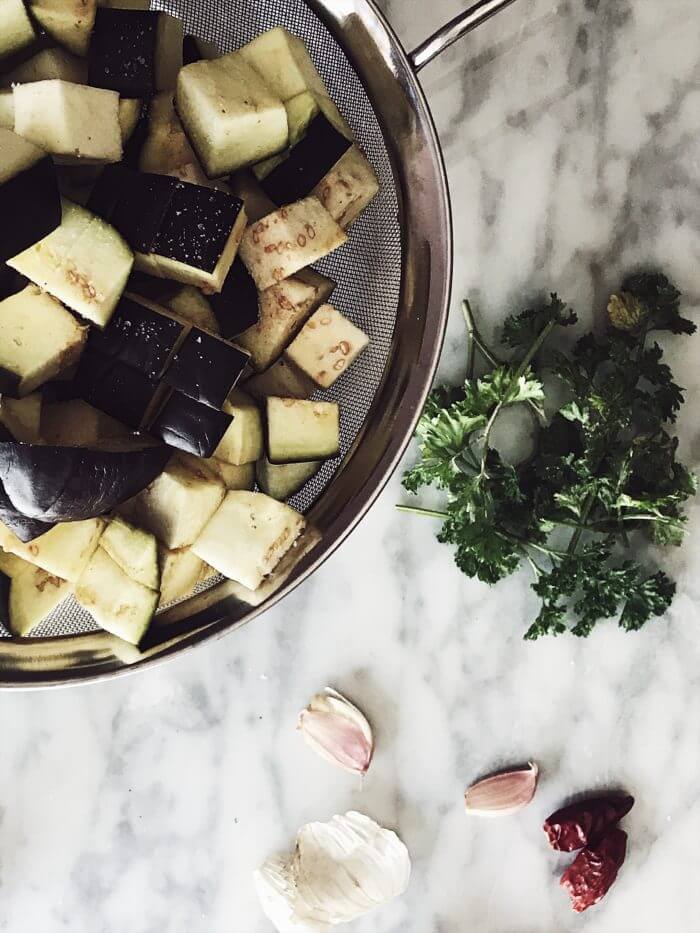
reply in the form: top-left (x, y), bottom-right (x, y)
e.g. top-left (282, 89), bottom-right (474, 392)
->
top-left (0, 285), bottom-right (87, 397)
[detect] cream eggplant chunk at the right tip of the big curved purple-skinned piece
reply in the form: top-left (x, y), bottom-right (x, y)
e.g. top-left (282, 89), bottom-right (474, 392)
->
top-left (119, 455), bottom-right (226, 550)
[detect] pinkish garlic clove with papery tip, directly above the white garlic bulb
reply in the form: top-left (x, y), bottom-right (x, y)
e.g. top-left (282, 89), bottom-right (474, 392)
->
top-left (297, 687), bottom-right (374, 774)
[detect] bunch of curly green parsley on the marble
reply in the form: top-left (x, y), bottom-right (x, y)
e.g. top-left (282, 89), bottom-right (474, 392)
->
top-left (399, 273), bottom-right (696, 639)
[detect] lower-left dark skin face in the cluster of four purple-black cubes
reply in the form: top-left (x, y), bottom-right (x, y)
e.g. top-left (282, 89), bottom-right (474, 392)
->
top-left (74, 349), bottom-right (163, 431)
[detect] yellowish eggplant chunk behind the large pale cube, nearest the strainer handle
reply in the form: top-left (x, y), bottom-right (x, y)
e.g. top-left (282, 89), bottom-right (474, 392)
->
top-left (240, 26), bottom-right (352, 139)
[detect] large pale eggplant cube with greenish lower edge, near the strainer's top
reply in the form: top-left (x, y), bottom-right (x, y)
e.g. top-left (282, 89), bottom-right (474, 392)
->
top-left (176, 52), bottom-right (288, 178)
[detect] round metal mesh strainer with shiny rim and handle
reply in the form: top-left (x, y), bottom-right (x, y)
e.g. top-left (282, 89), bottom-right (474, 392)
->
top-left (0, 0), bottom-right (513, 686)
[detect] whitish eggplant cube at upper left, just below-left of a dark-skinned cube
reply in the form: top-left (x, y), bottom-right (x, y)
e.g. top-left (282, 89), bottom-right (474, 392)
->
top-left (12, 80), bottom-right (122, 162)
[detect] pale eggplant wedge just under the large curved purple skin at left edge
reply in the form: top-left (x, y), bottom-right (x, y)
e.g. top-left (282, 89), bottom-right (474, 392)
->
top-left (0, 518), bottom-right (105, 581)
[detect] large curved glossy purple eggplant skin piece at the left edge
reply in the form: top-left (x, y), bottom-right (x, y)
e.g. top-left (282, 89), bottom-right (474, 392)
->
top-left (0, 440), bottom-right (172, 522)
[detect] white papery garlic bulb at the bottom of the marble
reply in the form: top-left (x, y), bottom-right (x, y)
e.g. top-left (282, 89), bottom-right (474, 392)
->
top-left (255, 811), bottom-right (411, 933)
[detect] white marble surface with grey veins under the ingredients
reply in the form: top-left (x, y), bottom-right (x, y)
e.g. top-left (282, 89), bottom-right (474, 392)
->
top-left (0, 0), bottom-right (700, 933)
